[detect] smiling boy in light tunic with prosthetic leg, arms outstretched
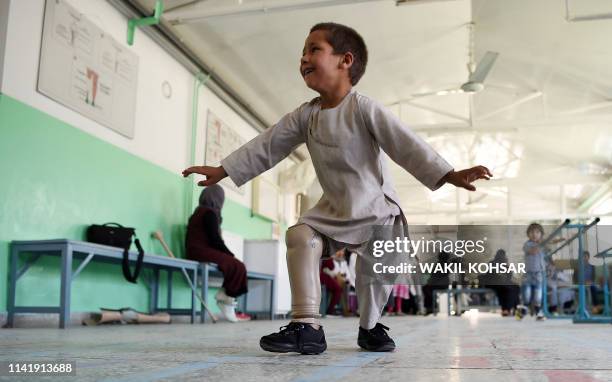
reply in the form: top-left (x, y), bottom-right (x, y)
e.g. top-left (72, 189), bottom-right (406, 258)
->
top-left (183, 23), bottom-right (491, 354)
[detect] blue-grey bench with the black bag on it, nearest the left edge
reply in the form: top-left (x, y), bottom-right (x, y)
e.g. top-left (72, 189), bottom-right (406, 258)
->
top-left (6, 239), bottom-right (200, 329)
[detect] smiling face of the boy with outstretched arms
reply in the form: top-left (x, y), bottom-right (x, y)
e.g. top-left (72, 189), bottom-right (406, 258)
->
top-left (300, 30), bottom-right (352, 94)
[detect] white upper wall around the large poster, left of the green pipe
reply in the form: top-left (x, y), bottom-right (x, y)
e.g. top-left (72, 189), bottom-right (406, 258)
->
top-left (1, 0), bottom-right (193, 174)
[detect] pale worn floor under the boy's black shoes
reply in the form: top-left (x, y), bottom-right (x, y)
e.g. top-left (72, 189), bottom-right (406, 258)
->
top-left (0, 313), bottom-right (612, 382)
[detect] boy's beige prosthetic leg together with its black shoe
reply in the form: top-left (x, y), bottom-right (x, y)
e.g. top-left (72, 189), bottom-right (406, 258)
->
top-left (259, 224), bottom-right (327, 354)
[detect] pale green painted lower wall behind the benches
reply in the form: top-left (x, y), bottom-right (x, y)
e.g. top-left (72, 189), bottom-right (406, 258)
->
top-left (0, 94), bottom-right (271, 312)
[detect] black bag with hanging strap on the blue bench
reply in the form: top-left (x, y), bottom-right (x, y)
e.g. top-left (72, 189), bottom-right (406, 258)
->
top-left (87, 223), bottom-right (144, 284)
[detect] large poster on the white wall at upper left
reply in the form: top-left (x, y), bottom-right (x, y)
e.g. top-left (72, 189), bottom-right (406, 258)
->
top-left (37, 0), bottom-right (138, 138)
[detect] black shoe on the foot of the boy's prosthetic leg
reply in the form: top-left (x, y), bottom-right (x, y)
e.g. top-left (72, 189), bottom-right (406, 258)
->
top-left (259, 322), bottom-right (327, 354)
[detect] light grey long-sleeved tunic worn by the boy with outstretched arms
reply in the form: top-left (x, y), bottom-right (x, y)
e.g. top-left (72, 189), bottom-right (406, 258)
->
top-left (221, 90), bottom-right (453, 244)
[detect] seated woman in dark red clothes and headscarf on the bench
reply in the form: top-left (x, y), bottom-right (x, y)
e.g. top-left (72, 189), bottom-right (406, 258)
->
top-left (185, 184), bottom-right (247, 322)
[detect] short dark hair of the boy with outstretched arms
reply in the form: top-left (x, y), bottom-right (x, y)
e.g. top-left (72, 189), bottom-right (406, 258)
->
top-left (310, 23), bottom-right (368, 86)
